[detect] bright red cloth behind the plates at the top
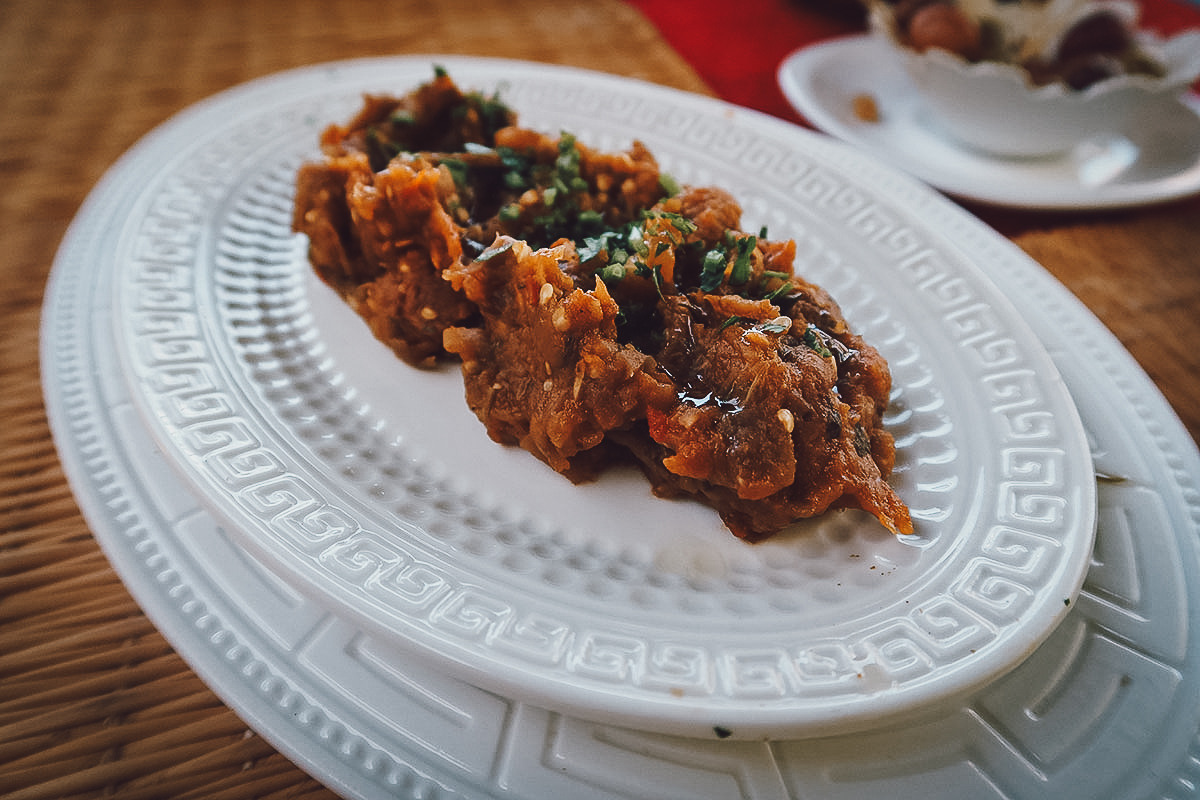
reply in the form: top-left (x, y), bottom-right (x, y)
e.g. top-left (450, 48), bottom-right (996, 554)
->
top-left (629, 0), bottom-right (1200, 122)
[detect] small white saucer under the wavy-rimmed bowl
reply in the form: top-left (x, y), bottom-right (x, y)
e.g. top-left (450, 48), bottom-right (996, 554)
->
top-left (778, 35), bottom-right (1200, 209)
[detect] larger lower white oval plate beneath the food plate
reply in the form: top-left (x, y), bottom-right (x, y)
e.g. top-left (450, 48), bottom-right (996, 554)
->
top-left (42, 57), bottom-right (1200, 800)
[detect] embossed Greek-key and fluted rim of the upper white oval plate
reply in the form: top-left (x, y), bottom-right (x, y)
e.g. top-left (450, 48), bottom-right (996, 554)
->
top-left (106, 58), bottom-right (1094, 738)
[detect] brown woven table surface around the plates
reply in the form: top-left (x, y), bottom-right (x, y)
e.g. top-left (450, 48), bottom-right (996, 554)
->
top-left (7, 0), bottom-right (1200, 799)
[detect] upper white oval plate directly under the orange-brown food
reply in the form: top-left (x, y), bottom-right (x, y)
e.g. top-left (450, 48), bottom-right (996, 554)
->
top-left (95, 58), bottom-right (1096, 738)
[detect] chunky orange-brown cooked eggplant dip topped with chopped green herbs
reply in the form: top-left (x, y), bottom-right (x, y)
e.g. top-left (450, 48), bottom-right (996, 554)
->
top-left (294, 70), bottom-right (912, 541)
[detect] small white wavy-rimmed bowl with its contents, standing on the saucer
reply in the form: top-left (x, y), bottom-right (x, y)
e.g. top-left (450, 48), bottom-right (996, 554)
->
top-left (870, 0), bottom-right (1200, 158)
